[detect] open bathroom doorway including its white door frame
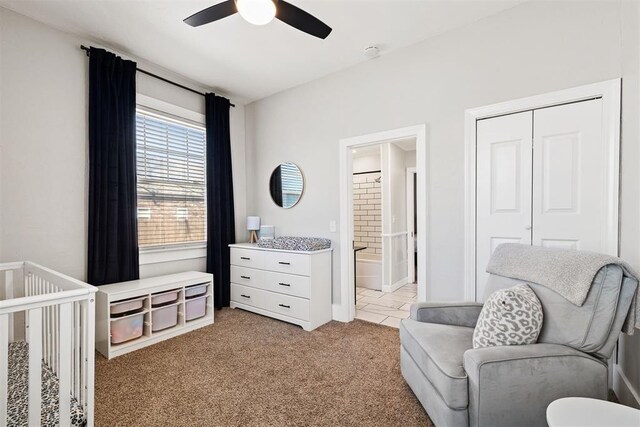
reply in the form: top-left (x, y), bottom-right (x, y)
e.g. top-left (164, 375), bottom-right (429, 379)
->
top-left (334, 125), bottom-right (428, 327)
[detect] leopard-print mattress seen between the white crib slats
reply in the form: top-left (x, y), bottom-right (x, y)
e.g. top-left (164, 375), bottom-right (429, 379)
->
top-left (6, 341), bottom-right (86, 427)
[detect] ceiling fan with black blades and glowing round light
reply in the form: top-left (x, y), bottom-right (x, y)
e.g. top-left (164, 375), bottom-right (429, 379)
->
top-left (184, 0), bottom-right (331, 39)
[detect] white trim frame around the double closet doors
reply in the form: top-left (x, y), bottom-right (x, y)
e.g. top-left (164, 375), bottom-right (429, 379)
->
top-left (464, 78), bottom-right (622, 301)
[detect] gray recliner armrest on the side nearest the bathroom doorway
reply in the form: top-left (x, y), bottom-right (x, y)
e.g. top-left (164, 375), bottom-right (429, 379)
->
top-left (411, 302), bottom-right (482, 328)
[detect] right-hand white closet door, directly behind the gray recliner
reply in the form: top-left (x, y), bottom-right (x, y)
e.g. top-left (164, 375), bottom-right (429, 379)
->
top-left (533, 99), bottom-right (607, 252)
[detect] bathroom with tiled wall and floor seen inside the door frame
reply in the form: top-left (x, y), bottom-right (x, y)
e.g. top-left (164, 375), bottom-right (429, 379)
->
top-left (351, 138), bottom-right (417, 327)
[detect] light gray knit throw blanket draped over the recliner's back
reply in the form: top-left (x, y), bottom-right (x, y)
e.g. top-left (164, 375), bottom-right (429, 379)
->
top-left (487, 243), bottom-right (640, 335)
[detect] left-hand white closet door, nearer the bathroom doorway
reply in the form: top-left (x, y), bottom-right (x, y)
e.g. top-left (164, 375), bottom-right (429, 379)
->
top-left (476, 111), bottom-right (533, 300)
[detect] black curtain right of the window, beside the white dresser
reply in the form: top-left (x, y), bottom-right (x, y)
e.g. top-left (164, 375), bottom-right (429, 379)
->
top-left (205, 93), bottom-right (236, 308)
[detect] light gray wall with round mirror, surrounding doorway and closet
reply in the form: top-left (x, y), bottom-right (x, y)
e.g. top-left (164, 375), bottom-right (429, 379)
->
top-left (246, 2), bottom-right (640, 408)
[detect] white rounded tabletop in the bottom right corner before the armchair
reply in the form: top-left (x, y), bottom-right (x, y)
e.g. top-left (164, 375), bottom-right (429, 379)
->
top-left (547, 397), bottom-right (640, 427)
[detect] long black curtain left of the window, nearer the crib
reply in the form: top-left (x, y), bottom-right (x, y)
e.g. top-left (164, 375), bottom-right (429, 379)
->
top-left (87, 47), bottom-right (139, 285)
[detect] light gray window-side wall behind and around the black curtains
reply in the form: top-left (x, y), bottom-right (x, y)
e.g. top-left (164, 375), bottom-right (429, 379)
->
top-left (0, 8), bottom-right (246, 279)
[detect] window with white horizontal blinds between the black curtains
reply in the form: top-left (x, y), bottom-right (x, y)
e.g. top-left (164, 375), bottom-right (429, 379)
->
top-left (136, 109), bottom-right (206, 248)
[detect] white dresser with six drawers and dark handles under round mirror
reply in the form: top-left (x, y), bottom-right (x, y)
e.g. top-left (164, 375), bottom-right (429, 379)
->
top-left (229, 243), bottom-right (332, 331)
